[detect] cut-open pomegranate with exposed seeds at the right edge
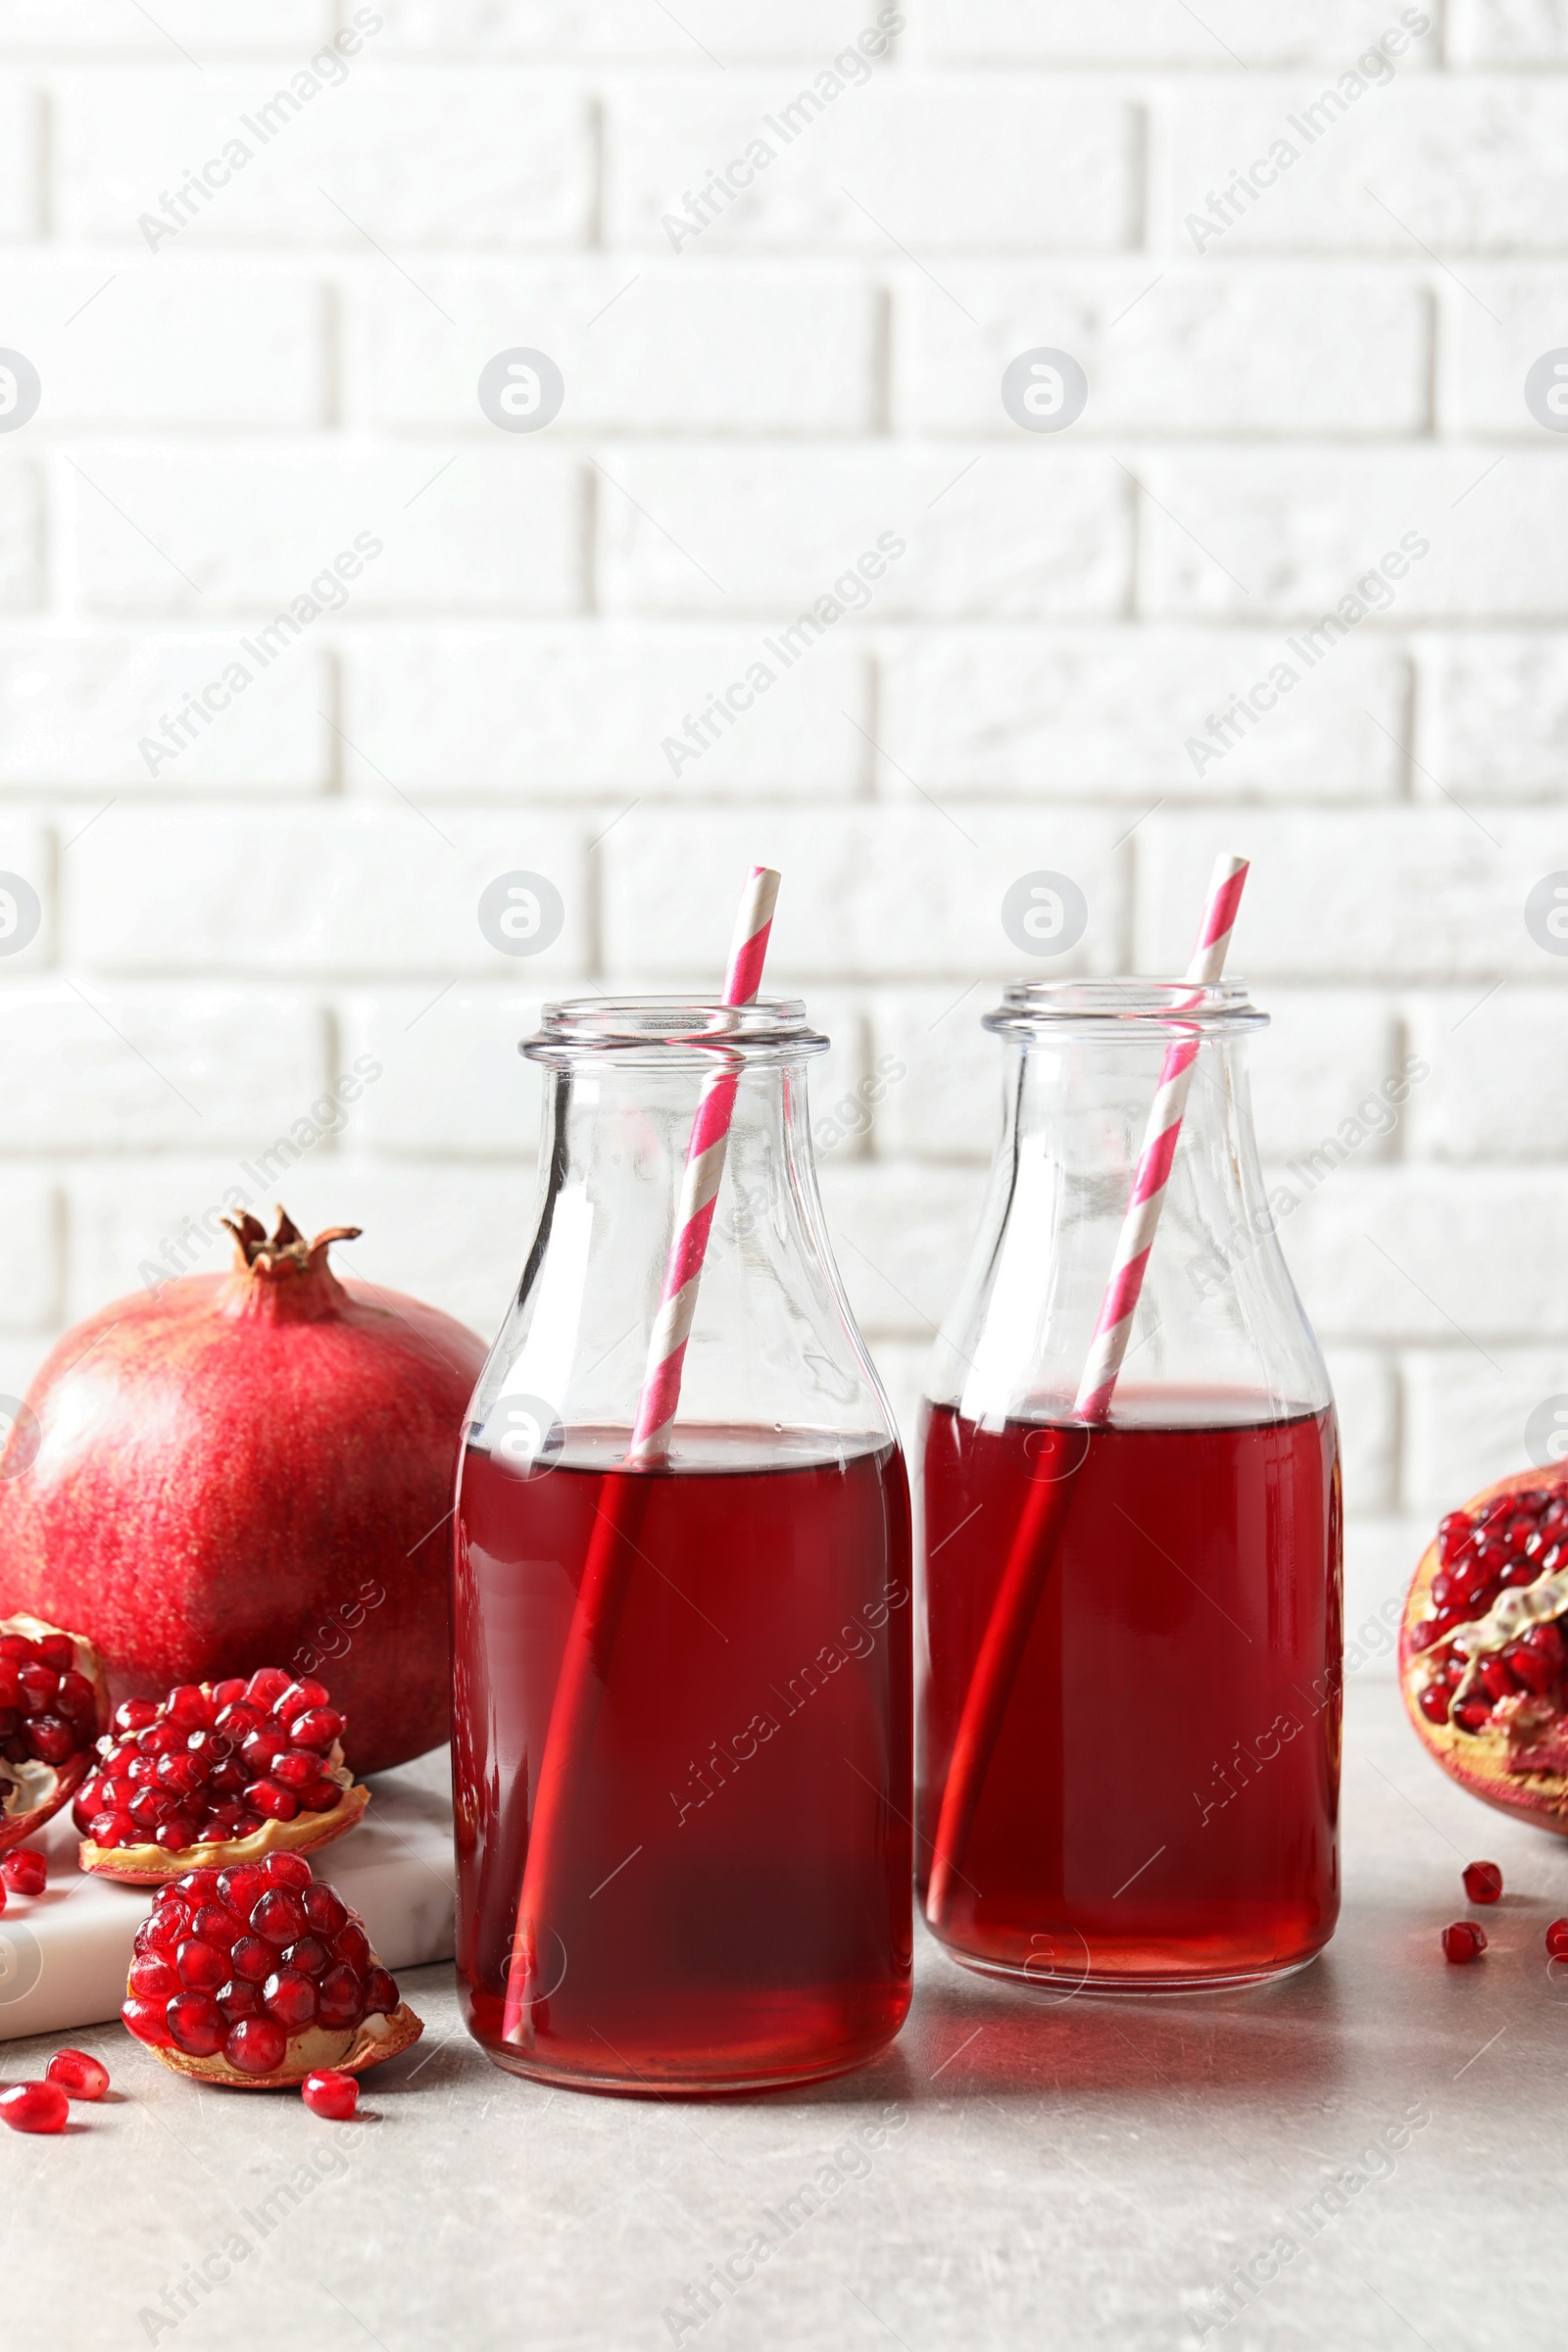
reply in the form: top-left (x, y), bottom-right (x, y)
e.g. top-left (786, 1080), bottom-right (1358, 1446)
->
top-left (1398, 1470), bottom-right (1568, 1837)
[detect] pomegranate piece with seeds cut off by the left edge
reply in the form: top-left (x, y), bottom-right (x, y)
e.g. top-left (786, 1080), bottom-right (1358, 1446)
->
top-left (0, 1616), bottom-right (108, 1853)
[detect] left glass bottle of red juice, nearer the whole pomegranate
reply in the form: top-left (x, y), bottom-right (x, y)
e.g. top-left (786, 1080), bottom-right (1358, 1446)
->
top-left (452, 998), bottom-right (912, 2093)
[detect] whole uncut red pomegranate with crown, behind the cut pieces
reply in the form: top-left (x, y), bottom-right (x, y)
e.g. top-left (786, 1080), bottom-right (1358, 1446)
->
top-left (0, 1209), bottom-right (484, 1771)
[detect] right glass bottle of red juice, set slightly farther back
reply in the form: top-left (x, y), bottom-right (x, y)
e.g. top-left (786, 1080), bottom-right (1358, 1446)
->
top-left (919, 981), bottom-right (1343, 1992)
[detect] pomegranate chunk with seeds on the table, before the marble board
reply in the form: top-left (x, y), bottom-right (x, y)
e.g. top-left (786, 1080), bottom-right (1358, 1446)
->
top-left (120, 1853), bottom-right (423, 2115)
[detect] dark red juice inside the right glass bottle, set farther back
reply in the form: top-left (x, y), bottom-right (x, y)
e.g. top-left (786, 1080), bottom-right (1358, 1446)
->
top-left (919, 1395), bottom-right (1343, 1989)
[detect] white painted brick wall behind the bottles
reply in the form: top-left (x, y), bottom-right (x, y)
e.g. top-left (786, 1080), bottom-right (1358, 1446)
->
top-left (0, 0), bottom-right (1568, 1674)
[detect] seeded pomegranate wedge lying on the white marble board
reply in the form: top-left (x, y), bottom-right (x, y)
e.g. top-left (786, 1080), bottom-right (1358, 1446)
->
top-left (75, 1665), bottom-right (369, 1886)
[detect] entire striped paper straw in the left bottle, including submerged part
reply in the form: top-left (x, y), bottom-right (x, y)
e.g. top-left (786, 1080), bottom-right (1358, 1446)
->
top-left (501, 865), bottom-right (778, 2048)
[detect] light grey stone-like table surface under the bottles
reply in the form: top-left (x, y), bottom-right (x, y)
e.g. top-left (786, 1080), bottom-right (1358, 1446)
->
top-left (0, 1687), bottom-right (1568, 2352)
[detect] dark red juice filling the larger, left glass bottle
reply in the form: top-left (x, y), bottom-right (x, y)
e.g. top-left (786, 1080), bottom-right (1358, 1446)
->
top-left (454, 1430), bottom-right (912, 2091)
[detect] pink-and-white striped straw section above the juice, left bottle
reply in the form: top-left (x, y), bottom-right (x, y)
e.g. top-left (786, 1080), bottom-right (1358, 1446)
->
top-left (625, 865), bottom-right (778, 1468)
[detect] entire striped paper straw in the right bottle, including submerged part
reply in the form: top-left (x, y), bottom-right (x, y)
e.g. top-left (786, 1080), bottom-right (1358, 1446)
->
top-left (926, 857), bottom-right (1246, 1927)
